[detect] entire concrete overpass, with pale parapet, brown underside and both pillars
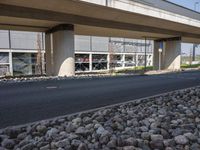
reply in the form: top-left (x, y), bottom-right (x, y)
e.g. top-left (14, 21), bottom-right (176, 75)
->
top-left (0, 0), bottom-right (200, 76)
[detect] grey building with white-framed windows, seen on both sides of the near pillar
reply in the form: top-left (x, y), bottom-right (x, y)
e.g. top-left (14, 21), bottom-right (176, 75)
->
top-left (0, 30), bottom-right (153, 75)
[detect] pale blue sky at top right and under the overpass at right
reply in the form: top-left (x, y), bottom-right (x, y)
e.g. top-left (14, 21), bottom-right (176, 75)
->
top-left (168, 0), bottom-right (200, 55)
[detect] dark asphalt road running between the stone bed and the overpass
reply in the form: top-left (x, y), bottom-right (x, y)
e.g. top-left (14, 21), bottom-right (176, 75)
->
top-left (0, 72), bottom-right (200, 128)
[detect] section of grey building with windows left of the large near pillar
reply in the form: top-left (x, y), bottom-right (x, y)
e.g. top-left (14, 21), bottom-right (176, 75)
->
top-left (0, 30), bottom-right (45, 75)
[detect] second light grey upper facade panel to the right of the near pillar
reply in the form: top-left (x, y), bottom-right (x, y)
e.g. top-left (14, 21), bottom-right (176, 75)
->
top-left (92, 36), bottom-right (109, 52)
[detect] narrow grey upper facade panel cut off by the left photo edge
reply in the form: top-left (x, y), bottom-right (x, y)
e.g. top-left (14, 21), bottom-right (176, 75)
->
top-left (0, 30), bottom-right (9, 48)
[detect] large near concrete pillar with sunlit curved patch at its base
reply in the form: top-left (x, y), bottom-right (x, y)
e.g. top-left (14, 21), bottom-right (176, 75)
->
top-left (47, 25), bottom-right (75, 76)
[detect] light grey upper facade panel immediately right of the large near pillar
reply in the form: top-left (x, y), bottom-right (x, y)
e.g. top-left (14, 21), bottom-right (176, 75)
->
top-left (75, 35), bottom-right (91, 51)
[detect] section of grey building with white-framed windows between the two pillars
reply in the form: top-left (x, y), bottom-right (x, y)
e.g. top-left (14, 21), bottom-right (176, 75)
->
top-left (75, 35), bottom-right (153, 72)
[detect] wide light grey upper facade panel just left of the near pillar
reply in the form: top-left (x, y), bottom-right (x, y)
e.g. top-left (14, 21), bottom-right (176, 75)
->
top-left (10, 31), bottom-right (43, 50)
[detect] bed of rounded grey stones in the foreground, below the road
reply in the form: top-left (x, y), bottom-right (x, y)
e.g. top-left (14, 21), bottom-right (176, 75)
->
top-left (0, 87), bottom-right (200, 150)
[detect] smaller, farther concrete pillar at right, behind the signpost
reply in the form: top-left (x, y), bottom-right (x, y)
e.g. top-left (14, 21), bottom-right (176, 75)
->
top-left (153, 39), bottom-right (181, 70)
